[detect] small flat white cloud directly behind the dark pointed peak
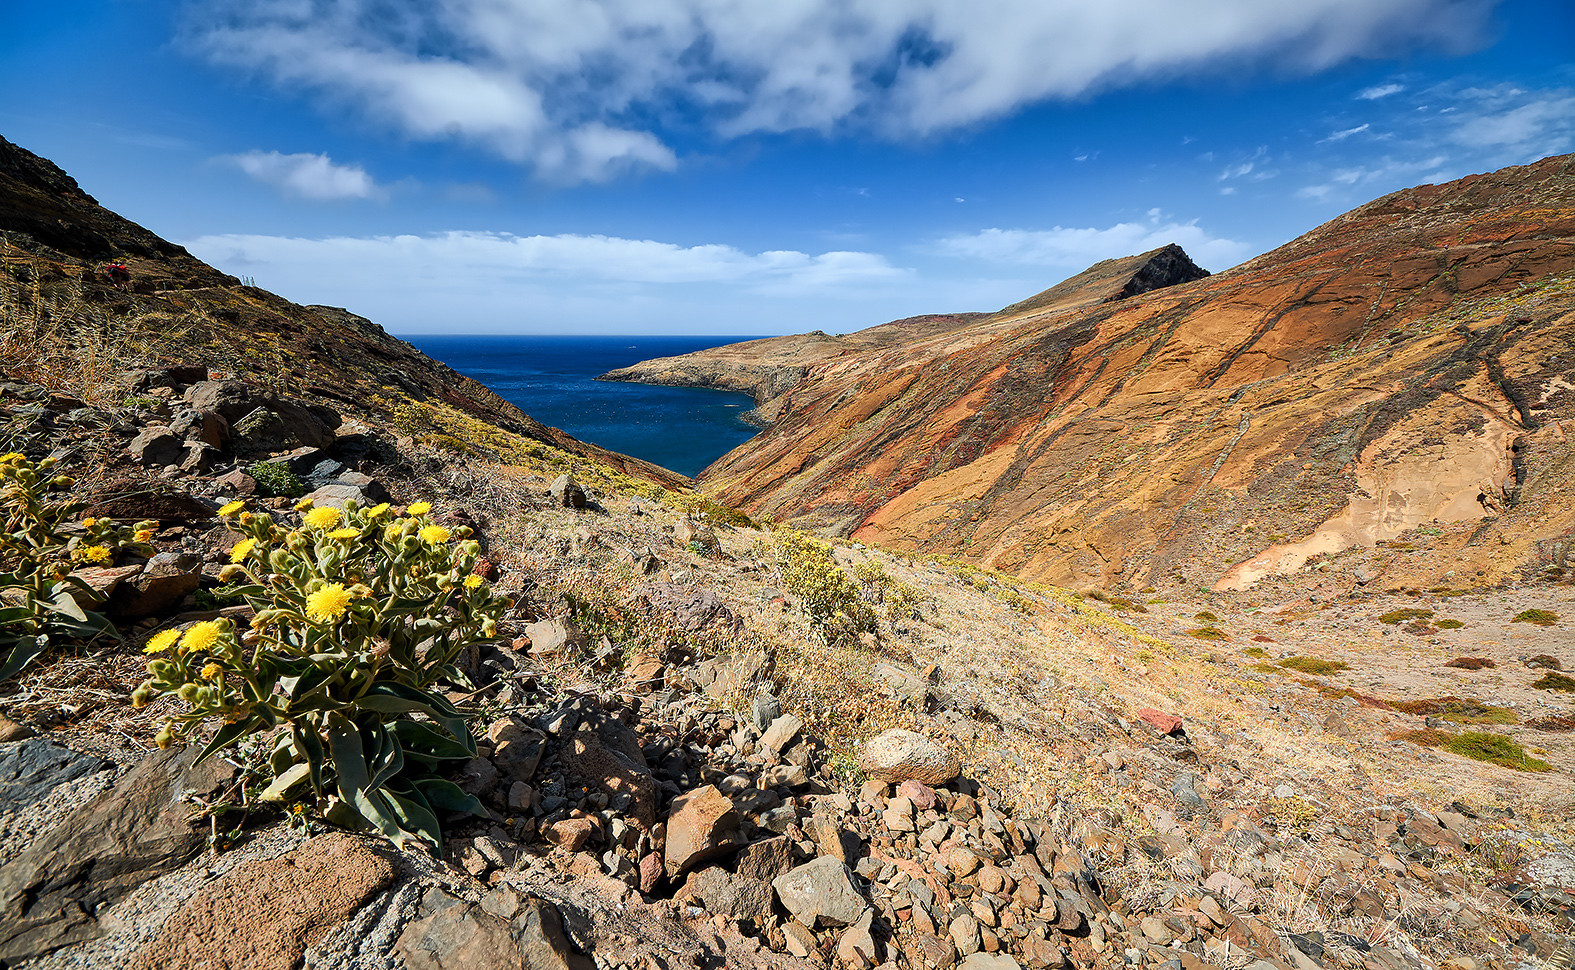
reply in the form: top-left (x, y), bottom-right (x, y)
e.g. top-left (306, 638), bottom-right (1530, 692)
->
top-left (936, 220), bottom-right (1252, 272)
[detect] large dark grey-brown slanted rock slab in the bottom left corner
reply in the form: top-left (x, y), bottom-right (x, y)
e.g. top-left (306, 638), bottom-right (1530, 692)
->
top-left (0, 748), bottom-right (230, 964)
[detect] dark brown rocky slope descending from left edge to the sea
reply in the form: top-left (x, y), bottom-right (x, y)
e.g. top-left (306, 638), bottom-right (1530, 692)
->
top-left (0, 139), bottom-right (687, 488)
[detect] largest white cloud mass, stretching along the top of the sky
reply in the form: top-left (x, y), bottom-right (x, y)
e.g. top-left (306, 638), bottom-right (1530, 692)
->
top-left (186, 0), bottom-right (1493, 181)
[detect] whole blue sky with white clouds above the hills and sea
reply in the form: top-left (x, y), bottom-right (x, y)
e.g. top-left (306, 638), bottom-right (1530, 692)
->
top-left (0, 0), bottom-right (1575, 334)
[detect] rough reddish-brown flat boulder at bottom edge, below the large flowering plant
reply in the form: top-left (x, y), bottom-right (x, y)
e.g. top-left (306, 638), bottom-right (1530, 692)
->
top-left (131, 833), bottom-right (394, 970)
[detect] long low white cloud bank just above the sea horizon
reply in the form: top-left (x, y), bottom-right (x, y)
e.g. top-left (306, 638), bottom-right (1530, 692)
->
top-left (183, 231), bottom-right (912, 334)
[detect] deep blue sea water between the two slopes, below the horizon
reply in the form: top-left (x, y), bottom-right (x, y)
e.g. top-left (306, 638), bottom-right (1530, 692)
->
top-left (405, 334), bottom-right (758, 476)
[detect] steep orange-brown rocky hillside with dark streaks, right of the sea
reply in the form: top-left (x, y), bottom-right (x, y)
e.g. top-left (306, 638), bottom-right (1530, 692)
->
top-left (607, 156), bottom-right (1575, 587)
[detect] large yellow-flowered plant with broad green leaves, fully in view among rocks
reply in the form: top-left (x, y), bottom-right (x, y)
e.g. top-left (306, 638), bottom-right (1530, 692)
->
top-left (132, 501), bottom-right (507, 844)
